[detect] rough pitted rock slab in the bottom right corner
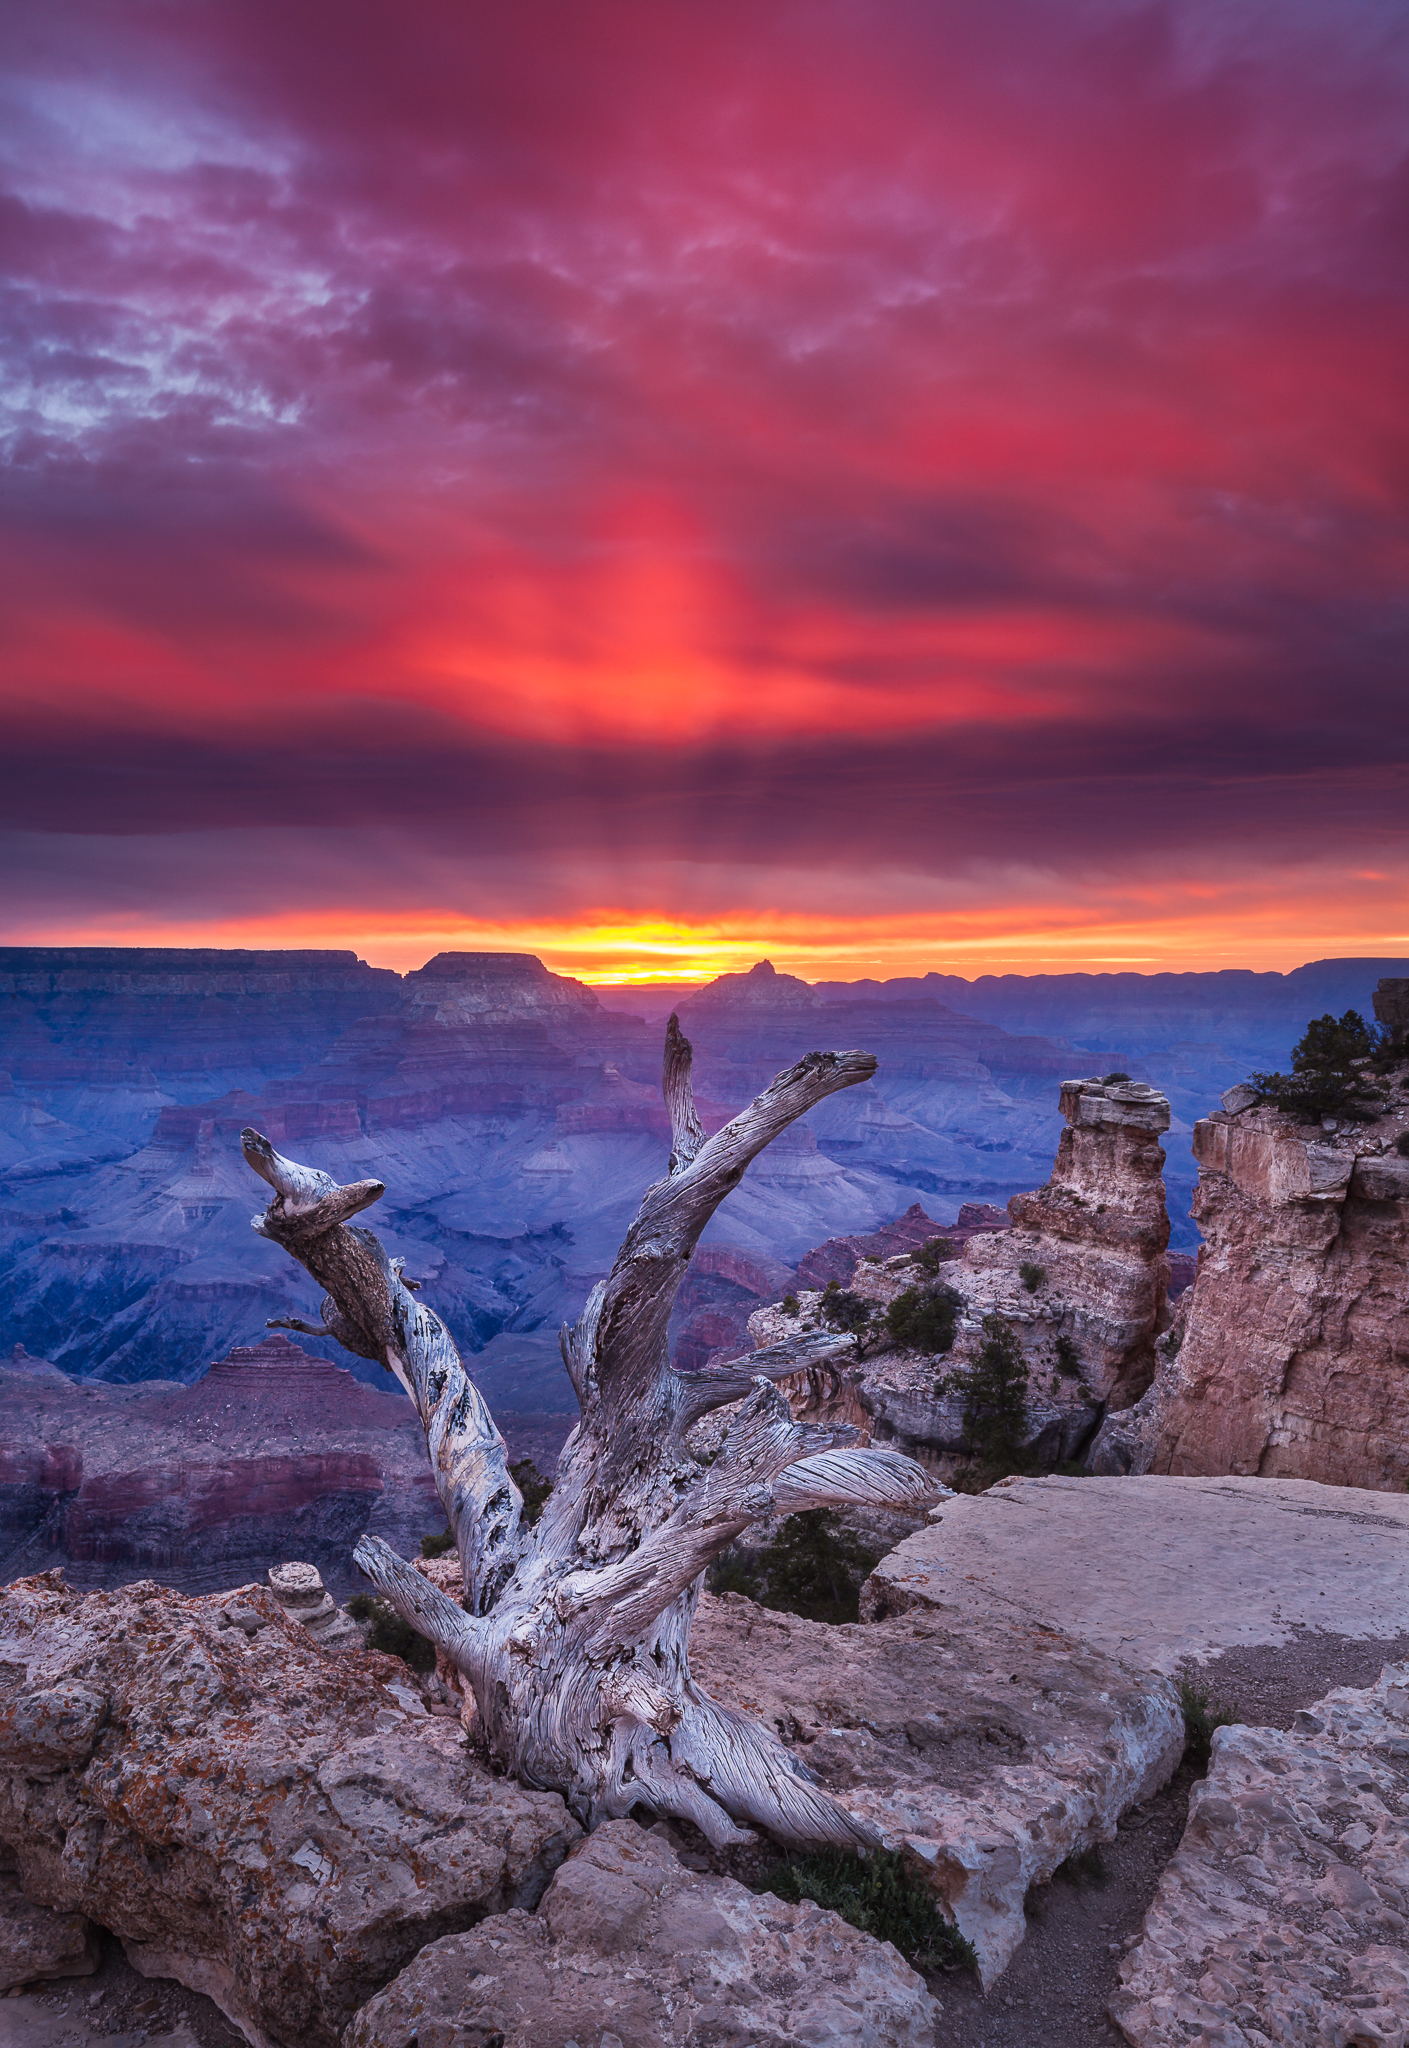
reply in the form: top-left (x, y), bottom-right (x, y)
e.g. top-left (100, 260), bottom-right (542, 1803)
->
top-left (1110, 1665), bottom-right (1409, 2048)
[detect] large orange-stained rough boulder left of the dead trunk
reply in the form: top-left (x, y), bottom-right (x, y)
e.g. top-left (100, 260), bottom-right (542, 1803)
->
top-left (0, 1571), bottom-right (580, 2048)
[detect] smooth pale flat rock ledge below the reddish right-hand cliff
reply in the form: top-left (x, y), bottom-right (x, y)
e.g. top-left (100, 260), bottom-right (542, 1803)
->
top-left (864, 1477), bottom-right (1409, 1671)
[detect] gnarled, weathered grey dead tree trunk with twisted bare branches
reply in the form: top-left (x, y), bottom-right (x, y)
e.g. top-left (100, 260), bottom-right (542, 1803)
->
top-left (244, 1018), bottom-right (934, 1845)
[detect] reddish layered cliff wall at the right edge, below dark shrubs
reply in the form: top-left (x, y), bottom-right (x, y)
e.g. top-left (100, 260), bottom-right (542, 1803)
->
top-left (1094, 1065), bottom-right (1409, 1493)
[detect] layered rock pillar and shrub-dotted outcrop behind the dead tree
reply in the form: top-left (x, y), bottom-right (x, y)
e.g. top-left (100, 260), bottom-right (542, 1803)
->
top-left (748, 1079), bottom-right (1171, 1479)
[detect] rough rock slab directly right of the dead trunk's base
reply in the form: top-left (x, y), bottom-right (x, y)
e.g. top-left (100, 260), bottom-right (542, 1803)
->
top-left (690, 1589), bottom-right (1184, 1982)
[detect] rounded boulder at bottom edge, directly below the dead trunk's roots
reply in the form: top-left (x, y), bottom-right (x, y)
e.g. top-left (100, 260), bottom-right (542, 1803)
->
top-left (342, 1821), bottom-right (940, 2048)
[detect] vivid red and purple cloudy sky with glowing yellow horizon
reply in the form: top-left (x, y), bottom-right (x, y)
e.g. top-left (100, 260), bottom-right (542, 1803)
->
top-left (0, 0), bottom-right (1409, 979)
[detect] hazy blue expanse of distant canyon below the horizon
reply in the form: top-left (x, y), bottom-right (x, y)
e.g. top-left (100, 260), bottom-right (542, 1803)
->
top-left (0, 946), bottom-right (1405, 1413)
